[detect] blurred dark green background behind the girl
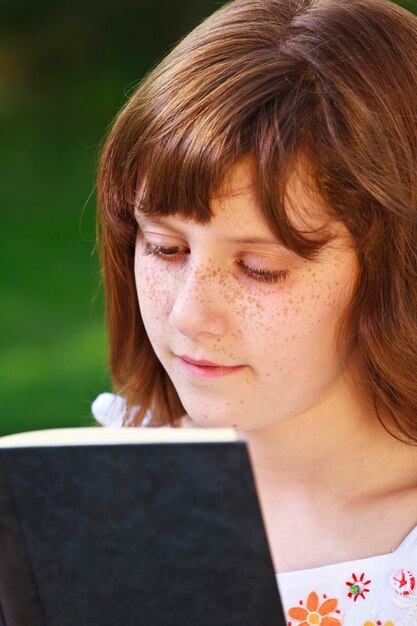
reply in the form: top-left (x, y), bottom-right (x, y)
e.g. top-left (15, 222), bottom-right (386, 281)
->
top-left (0, 0), bottom-right (417, 435)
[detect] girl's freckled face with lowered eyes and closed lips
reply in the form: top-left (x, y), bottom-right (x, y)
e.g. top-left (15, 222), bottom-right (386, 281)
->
top-left (135, 161), bottom-right (358, 430)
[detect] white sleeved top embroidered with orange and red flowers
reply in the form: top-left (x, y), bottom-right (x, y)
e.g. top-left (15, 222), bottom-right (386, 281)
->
top-left (92, 393), bottom-right (417, 626)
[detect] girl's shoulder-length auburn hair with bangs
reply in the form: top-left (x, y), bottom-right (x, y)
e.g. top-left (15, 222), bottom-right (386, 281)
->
top-left (98, 0), bottom-right (417, 434)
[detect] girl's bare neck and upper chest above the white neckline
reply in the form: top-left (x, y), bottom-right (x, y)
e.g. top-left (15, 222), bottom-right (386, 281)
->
top-left (240, 370), bottom-right (417, 571)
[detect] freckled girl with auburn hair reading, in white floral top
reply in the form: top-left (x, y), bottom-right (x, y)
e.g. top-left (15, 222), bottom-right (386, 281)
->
top-left (95, 0), bottom-right (417, 626)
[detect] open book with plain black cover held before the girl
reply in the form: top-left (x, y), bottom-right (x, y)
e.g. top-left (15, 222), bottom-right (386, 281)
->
top-left (0, 427), bottom-right (285, 626)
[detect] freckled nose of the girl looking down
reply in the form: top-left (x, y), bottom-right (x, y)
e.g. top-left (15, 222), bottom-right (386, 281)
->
top-left (169, 268), bottom-right (226, 339)
